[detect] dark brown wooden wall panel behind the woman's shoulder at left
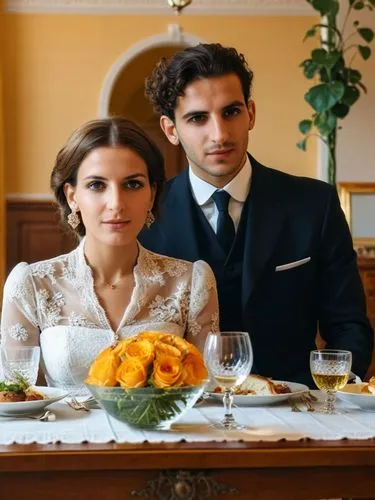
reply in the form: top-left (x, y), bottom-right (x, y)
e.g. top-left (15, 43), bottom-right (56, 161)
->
top-left (7, 200), bottom-right (77, 273)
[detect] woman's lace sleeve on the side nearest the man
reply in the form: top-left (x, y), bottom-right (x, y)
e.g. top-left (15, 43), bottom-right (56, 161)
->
top-left (186, 260), bottom-right (219, 352)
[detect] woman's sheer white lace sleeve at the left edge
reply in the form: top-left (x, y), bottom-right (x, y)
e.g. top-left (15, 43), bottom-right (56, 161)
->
top-left (1, 262), bottom-right (39, 345)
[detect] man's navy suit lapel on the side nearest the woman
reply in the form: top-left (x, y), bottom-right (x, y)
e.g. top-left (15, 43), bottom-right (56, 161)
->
top-left (163, 169), bottom-right (200, 262)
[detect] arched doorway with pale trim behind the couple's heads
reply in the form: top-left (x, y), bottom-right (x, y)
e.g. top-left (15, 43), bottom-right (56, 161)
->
top-left (99, 29), bottom-right (201, 178)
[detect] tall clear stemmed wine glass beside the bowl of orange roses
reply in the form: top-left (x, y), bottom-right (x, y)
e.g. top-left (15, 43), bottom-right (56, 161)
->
top-left (204, 332), bottom-right (253, 430)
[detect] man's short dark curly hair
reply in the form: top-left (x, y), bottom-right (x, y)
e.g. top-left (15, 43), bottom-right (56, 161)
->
top-left (145, 43), bottom-right (253, 121)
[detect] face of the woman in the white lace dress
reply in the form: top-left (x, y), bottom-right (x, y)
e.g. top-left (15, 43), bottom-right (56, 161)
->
top-left (64, 147), bottom-right (155, 246)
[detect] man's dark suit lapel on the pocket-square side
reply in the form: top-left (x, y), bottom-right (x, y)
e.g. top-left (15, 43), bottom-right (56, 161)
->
top-left (242, 157), bottom-right (285, 309)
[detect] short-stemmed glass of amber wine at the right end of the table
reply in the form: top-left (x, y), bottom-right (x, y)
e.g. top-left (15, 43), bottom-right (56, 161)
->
top-left (310, 349), bottom-right (352, 413)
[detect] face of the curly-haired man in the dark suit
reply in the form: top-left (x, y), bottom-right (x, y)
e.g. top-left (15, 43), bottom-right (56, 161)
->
top-left (160, 73), bottom-right (255, 187)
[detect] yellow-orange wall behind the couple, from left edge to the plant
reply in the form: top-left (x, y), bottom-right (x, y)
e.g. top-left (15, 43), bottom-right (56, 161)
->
top-left (4, 13), bottom-right (316, 193)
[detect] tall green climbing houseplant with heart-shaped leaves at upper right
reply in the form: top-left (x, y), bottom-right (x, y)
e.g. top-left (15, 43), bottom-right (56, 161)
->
top-left (297, 0), bottom-right (375, 184)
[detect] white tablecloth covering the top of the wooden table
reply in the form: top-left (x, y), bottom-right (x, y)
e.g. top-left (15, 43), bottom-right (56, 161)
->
top-left (0, 391), bottom-right (375, 445)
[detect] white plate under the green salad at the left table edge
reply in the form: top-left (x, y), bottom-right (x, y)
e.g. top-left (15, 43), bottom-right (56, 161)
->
top-left (0, 386), bottom-right (68, 417)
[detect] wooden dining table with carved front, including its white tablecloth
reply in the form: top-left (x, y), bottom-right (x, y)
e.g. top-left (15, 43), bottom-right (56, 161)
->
top-left (0, 392), bottom-right (375, 500)
